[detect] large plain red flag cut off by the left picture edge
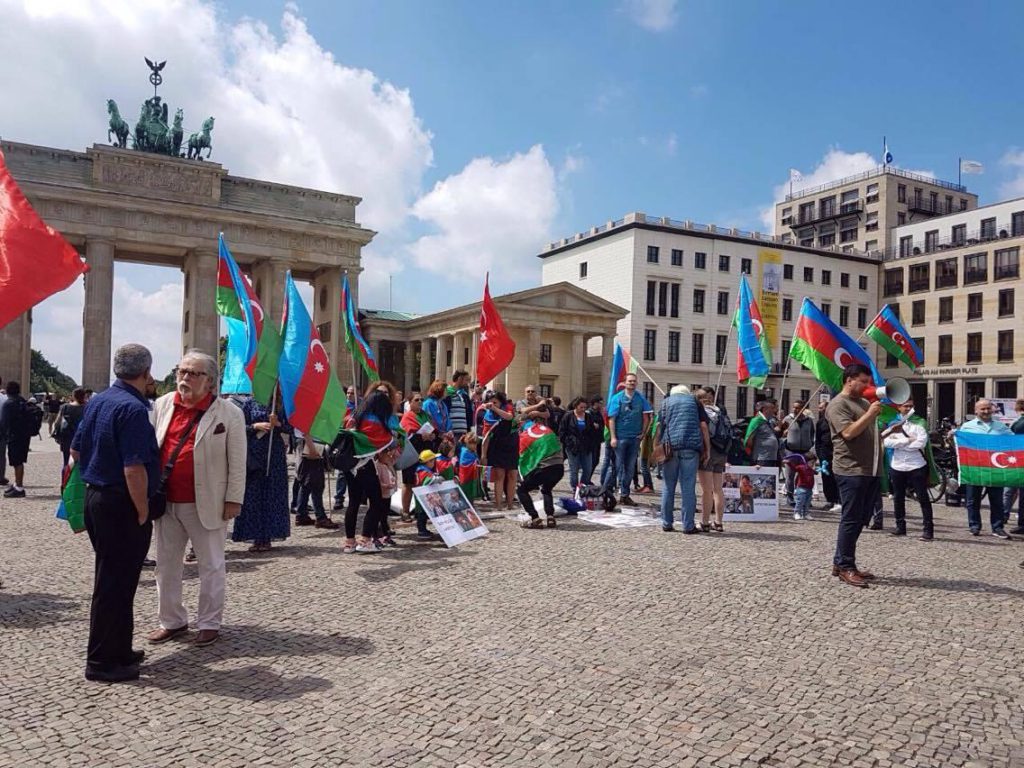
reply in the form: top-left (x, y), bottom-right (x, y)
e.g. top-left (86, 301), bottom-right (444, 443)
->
top-left (0, 153), bottom-right (89, 328)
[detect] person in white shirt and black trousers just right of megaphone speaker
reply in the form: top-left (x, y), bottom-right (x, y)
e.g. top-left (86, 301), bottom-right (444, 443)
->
top-left (882, 402), bottom-right (935, 542)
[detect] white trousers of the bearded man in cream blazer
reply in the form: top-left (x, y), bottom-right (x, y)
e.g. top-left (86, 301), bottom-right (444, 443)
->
top-left (154, 503), bottom-right (227, 630)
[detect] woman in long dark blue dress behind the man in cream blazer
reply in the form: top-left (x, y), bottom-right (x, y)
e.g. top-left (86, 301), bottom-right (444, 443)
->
top-left (231, 396), bottom-right (293, 552)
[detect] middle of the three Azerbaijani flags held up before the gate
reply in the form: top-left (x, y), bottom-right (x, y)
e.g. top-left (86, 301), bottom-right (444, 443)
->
top-left (280, 271), bottom-right (346, 444)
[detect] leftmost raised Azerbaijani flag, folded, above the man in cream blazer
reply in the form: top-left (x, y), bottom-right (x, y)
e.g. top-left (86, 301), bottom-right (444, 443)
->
top-left (217, 233), bottom-right (282, 406)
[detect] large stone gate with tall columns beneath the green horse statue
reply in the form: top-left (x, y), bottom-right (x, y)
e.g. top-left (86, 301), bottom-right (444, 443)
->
top-left (0, 141), bottom-right (375, 391)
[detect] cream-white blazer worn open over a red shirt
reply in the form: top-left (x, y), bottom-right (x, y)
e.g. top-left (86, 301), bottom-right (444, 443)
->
top-left (152, 392), bottom-right (249, 530)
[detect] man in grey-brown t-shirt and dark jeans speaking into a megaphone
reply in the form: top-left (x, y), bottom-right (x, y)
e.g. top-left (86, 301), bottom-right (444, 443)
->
top-left (825, 362), bottom-right (882, 587)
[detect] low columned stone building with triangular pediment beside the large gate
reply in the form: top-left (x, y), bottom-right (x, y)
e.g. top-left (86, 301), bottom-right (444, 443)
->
top-left (360, 283), bottom-right (626, 402)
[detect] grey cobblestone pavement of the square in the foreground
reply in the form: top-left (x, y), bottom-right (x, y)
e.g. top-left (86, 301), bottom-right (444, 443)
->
top-left (0, 442), bottom-right (1024, 768)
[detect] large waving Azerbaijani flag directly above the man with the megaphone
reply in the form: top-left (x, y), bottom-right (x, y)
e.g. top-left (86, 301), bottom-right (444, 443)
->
top-left (790, 298), bottom-right (885, 392)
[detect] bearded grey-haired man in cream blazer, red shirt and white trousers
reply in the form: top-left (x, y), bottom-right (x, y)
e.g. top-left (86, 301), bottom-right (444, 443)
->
top-left (150, 350), bottom-right (247, 646)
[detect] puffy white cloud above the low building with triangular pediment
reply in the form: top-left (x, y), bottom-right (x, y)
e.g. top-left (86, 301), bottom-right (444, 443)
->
top-left (409, 145), bottom-right (558, 282)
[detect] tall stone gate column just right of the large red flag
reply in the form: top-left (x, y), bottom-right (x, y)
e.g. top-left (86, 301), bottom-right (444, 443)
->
top-left (82, 238), bottom-right (115, 392)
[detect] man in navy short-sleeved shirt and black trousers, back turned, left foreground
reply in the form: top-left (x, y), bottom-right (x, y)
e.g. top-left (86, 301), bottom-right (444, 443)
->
top-left (71, 344), bottom-right (160, 683)
